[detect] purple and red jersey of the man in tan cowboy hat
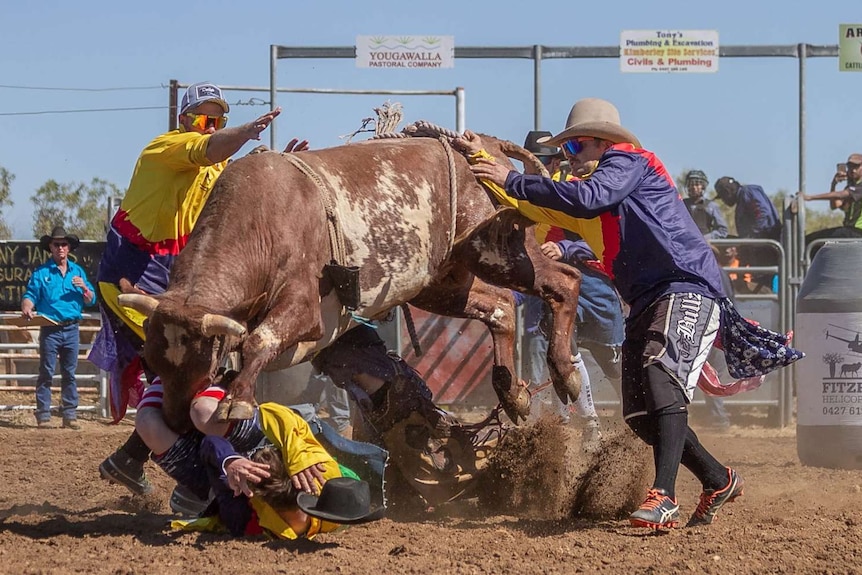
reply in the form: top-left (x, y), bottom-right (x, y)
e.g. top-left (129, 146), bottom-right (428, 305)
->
top-left (505, 144), bottom-right (726, 318)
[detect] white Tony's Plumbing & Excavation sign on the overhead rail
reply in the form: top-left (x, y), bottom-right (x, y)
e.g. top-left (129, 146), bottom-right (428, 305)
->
top-left (620, 30), bottom-right (718, 72)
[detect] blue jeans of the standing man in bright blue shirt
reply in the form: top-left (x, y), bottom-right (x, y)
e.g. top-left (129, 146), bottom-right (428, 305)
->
top-left (36, 323), bottom-right (79, 421)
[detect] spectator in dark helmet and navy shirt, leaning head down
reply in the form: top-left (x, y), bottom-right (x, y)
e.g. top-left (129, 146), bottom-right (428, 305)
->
top-left (715, 176), bottom-right (781, 291)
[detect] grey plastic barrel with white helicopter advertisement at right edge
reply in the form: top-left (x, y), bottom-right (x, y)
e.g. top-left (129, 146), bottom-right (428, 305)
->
top-left (795, 240), bottom-right (862, 469)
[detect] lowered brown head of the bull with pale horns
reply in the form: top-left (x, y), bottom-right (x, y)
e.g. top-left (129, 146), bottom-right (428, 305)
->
top-left (119, 294), bottom-right (246, 432)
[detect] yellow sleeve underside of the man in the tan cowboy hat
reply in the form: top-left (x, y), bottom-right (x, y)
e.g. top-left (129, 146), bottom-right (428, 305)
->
top-left (467, 150), bottom-right (604, 259)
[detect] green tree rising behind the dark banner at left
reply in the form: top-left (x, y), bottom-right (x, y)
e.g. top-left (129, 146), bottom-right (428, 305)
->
top-left (30, 178), bottom-right (122, 240)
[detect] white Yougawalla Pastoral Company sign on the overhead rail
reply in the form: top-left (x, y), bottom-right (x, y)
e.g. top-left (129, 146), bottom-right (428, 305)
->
top-left (356, 36), bottom-right (455, 70)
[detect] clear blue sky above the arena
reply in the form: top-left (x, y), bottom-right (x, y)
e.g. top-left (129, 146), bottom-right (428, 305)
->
top-left (0, 0), bottom-right (862, 239)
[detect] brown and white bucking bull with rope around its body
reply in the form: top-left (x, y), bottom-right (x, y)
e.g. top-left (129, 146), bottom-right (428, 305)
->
top-left (121, 137), bottom-right (580, 430)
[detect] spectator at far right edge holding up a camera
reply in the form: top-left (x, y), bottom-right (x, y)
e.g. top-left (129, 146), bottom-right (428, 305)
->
top-left (800, 154), bottom-right (862, 244)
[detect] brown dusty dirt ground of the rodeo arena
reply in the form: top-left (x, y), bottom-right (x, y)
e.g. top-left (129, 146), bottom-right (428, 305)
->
top-left (0, 400), bottom-right (862, 574)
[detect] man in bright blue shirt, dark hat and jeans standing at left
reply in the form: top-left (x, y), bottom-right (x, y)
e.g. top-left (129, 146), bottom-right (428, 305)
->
top-left (21, 226), bottom-right (96, 429)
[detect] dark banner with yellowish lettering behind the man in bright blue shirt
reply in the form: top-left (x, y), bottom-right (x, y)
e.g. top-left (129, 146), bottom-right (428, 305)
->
top-left (0, 241), bottom-right (105, 312)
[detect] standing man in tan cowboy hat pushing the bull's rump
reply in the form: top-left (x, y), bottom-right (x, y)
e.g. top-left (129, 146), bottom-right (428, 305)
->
top-left (456, 98), bottom-right (803, 529)
